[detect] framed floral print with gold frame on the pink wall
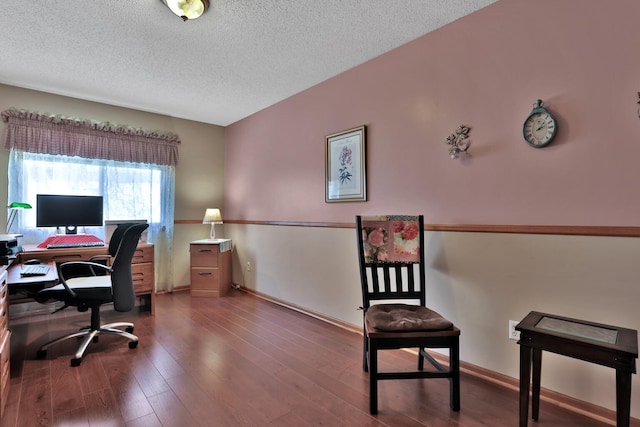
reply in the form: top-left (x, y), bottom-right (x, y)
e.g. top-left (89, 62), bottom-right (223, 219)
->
top-left (325, 126), bottom-right (367, 202)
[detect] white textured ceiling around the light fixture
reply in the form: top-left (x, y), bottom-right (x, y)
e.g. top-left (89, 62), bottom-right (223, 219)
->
top-left (0, 0), bottom-right (496, 126)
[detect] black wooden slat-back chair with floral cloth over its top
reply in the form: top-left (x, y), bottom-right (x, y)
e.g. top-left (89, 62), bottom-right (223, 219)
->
top-left (356, 215), bottom-right (460, 414)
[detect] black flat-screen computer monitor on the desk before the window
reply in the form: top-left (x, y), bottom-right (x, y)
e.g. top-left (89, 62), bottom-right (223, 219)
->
top-left (36, 194), bottom-right (103, 234)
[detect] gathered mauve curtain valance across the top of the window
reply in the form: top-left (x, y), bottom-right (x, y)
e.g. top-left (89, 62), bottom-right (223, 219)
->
top-left (1, 108), bottom-right (180, 166)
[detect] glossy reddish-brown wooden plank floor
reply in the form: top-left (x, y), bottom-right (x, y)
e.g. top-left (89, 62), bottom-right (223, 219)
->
top-left (0, 291), bottom-right (624, 427)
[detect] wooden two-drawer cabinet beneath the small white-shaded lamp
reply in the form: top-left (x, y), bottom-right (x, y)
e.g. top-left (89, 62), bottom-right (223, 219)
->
top-left (189, 239), bottom-right (231, 297)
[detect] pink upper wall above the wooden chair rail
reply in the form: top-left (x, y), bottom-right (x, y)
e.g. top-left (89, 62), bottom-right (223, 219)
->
top-left (225, 0), bottom-right (640, 226)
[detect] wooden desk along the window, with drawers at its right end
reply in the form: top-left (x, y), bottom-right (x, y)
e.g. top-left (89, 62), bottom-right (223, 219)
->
top-left (16, 243), bottom-right (155, 314)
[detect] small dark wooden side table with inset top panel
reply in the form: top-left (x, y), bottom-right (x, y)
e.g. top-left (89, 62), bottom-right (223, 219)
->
top-left (516, 311), bottom-right (638, 427)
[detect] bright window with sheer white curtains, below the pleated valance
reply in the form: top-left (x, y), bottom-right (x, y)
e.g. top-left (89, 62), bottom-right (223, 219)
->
top-left (9, 150), bottom-right (175, 289)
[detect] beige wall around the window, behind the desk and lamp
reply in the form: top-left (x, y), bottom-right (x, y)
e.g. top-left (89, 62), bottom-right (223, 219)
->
top-left (0, 84), bottom-right (224, 286)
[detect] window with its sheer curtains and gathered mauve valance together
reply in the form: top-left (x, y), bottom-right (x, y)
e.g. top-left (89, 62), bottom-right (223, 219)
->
top-left (0, 108), bottom-right (180, 290)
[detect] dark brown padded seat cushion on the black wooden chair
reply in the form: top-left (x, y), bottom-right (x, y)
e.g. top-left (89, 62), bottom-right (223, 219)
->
top-left (365, 304), bottom-right (453, 331)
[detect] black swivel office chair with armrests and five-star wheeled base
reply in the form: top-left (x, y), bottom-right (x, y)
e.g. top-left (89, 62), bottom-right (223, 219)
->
top-left (35, 224), bottom-right (149, 366)
